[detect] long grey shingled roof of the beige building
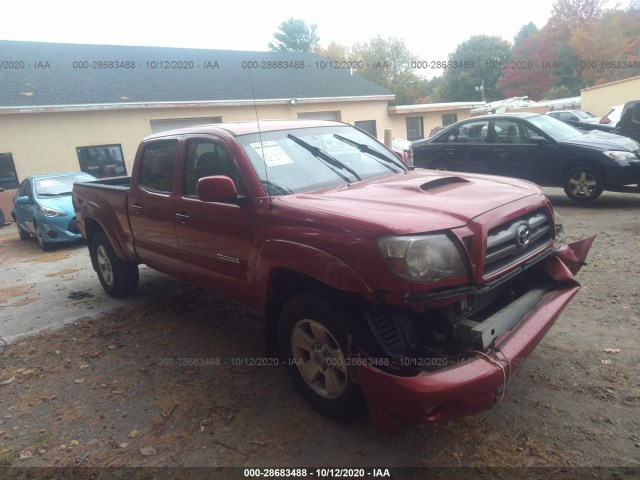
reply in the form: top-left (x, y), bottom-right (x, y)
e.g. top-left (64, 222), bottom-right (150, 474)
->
top-left (0, 40), bottom-right (393, 108)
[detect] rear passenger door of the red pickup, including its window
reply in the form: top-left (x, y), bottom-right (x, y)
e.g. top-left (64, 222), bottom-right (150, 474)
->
top-left (127, 138), bottom-right (180, 274)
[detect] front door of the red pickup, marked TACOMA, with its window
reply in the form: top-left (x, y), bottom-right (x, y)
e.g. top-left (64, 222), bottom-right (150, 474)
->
top-left (174, 136), bottom-right (254, 303)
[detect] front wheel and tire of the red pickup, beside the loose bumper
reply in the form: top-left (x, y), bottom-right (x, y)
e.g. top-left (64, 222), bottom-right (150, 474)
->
top-left (278, 294), bottom-right (366, 421)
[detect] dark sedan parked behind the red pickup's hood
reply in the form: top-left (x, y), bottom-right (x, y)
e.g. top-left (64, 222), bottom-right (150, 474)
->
top-left (413, 113), bottom-right (640, 202)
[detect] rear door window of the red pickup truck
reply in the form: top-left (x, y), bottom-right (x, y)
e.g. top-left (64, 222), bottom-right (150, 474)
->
top-left (138, 140), bottom-right (178, 193)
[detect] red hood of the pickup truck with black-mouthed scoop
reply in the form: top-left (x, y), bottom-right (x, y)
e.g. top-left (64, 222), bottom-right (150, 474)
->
top-left (278, 169), bottom-right (542, 234)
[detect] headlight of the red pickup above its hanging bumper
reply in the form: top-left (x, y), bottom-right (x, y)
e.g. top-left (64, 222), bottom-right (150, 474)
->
top-left (378, 234), bottom-right (467, 282)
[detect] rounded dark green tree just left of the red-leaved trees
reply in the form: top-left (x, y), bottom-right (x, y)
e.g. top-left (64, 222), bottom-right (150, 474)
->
top-left (441, 35), bottom-right (511, 102)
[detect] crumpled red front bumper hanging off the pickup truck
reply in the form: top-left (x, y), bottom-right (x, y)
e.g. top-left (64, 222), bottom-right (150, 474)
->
top-left (358, 237), bottom-right (595, 432)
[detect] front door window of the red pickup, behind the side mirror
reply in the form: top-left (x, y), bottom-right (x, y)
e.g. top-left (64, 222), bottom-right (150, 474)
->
top-left (184, 140), bottom-right (245, 197)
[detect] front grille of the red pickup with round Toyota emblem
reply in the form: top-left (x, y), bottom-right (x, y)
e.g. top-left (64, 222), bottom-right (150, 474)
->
top-left (485, 210), bottom-right (553, 275)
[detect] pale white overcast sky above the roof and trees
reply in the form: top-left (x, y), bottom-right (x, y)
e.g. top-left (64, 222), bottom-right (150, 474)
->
top-left (0, 0), bottom-right (629, 76)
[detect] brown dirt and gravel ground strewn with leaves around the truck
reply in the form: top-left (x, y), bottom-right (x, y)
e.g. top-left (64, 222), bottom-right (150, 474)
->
top-left (0, 189), bottom-right (640, 479)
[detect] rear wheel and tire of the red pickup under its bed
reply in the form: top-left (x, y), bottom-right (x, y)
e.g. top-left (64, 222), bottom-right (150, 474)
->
top-left (89, 232), bottom-right (140, 297)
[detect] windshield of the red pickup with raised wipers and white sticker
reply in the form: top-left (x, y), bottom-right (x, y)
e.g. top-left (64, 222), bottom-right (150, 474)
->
top-left (238, 125), bottom-right (406, 195)
